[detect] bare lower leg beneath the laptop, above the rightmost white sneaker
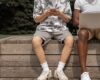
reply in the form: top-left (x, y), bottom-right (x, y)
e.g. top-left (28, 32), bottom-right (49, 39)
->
top-left (77, 29), bottom-right (89, 73)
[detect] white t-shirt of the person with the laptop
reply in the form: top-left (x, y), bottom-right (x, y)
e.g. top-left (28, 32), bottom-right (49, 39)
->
top-left (74, 0), bottom-right (100, 12)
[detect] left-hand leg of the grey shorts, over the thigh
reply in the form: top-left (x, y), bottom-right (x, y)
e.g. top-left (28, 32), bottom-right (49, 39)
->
top-left (33, 30), bottom-right (52, 46)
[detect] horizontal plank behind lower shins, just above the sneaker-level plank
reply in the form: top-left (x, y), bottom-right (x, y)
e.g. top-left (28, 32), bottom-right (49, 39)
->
top-left (0, 55), bottom-right (100, 67)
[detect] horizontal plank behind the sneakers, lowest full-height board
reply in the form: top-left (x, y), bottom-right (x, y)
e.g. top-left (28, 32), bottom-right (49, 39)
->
top-left (0, 67), bottom-right (100, 79)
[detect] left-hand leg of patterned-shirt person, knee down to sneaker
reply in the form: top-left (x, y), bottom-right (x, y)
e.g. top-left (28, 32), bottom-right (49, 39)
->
top-left (32, 37), bottom-right (52, 80)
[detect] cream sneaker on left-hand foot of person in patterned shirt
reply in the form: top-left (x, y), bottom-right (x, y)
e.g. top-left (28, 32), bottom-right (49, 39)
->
top-left (37, 70), bottom-right (52, 80)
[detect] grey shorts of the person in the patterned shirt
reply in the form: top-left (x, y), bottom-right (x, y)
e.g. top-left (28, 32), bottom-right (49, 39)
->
top-left (33, 30), bottom-right (72, 45)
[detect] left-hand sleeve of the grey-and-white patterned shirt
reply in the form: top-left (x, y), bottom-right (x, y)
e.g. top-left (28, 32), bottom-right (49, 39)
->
top-left (33, 0), bottom-right (43, 19)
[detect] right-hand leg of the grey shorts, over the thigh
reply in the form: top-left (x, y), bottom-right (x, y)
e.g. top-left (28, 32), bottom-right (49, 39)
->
top-left (54, 30), bottom-right (73, 43)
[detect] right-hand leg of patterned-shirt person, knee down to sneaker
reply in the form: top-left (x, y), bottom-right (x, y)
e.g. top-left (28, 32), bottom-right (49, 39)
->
top-left (54, 36), bottom-right (73, 80)
